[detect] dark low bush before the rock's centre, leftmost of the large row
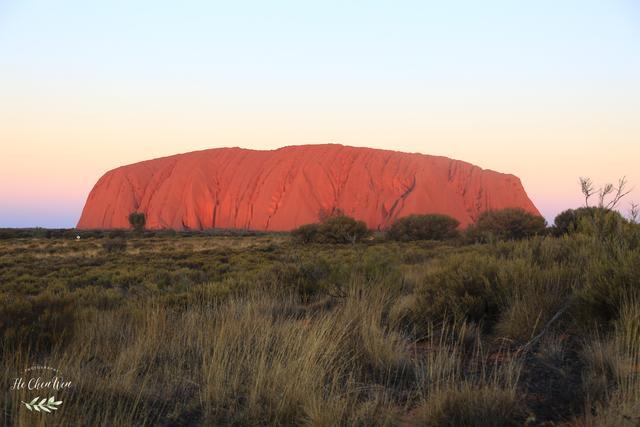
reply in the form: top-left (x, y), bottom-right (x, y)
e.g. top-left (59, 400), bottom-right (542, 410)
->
top-left (292, 214), bottom-right (371, 243)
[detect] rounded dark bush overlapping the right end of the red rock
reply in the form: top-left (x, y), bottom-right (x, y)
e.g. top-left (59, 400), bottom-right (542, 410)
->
top-left (467, 208), bottom-right (546, 241)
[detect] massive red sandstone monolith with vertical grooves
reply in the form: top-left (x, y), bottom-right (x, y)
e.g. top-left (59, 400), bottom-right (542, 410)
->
top-left (77, 144), bottom-right (539, 230)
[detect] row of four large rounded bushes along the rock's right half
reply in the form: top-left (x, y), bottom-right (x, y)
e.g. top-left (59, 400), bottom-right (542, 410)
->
top-left (292, 178), bottom-right (640, 243)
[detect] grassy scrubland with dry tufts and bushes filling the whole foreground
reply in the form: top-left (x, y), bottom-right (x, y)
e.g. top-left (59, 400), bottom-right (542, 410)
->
top-left (0, 203), bottom-right (640, 426)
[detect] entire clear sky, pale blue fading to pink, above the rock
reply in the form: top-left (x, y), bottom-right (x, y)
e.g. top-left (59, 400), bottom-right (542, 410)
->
top-left (0, 0), bottom-right (640, 227)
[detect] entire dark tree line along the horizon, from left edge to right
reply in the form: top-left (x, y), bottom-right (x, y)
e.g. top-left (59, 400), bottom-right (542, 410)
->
top-left (0, 178), bottom-right (640, 244)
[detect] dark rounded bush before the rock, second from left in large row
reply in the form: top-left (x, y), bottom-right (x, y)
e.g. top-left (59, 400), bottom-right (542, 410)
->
top-left (387, 214), bottom-right (460, 241)
